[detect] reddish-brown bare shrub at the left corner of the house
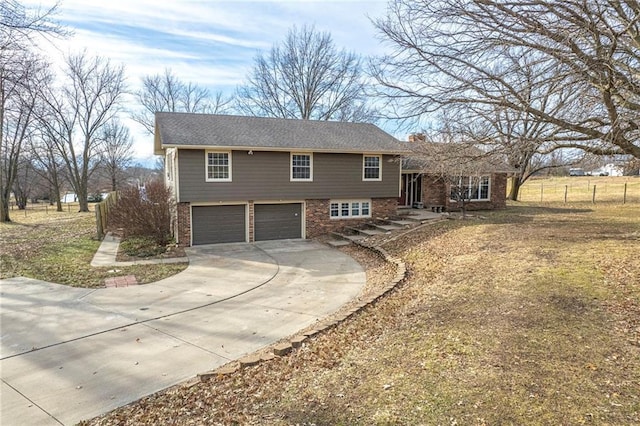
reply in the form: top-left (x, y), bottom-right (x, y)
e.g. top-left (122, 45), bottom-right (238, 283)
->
top-left (108, 180), bottom-right (173, 246)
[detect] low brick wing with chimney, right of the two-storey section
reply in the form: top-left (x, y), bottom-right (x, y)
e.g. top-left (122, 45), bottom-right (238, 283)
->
top-left (399, 133), bottom-right (514, 211)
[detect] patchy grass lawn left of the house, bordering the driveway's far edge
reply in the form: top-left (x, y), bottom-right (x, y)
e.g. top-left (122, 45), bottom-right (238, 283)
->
top-left (0, 206), bottom-right (186, 287)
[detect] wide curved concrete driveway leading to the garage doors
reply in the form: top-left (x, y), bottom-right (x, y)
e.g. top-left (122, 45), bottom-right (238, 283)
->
top-left (0, 240), bottom-right (366, 426)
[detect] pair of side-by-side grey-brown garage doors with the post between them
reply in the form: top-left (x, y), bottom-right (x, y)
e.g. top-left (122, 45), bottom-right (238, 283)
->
top-left (191, 203), bottom-right (304, 245)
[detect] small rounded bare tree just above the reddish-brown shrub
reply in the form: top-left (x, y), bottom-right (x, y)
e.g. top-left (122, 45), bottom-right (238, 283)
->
top-left (99, 120), bottom-right (133, 191)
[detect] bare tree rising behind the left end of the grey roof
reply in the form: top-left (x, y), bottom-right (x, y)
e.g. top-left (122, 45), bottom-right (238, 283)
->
top-left (131, 68), bottom-right (231, 134)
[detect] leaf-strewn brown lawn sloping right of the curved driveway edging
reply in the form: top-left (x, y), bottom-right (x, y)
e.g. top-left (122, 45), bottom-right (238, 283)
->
top-left (87, 202), bottom-right (640, 425)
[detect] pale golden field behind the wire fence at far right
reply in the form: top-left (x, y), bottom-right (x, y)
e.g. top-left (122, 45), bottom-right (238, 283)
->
top-left (520, 176), bottom-right (640, 204)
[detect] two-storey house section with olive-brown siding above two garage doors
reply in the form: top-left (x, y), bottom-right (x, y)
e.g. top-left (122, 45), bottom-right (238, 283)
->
top-left (154, 112), bottom-right (406, 245)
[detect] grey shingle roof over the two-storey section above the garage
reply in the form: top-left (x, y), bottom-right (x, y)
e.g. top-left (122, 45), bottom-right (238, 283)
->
top-left (155, 112), bottom-right (408, 154)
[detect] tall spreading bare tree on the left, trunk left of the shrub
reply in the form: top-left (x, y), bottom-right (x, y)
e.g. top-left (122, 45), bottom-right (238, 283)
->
top-left (40, 52), bottom-right (125, 212)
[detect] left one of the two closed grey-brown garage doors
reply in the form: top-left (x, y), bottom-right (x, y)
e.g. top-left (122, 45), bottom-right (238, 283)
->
top-left (191, 205), bottom-right (247, 245)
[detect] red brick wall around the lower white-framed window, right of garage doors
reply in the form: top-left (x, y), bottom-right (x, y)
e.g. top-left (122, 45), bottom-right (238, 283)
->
top-left (305, 198), bottom-right (398, 238)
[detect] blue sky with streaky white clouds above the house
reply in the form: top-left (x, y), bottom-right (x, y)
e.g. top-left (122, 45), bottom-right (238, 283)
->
top-left (22, 0), bottom-right (386, 160)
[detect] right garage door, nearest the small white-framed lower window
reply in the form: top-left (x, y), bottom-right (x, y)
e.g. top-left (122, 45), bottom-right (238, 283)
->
top-left (254, 203), bottom-right (302, 241)
